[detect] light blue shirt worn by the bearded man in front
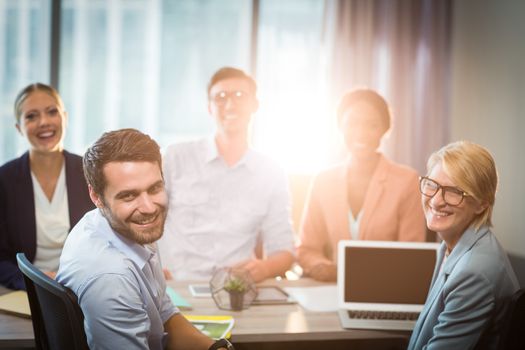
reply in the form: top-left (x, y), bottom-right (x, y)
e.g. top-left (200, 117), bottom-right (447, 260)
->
top-left (57, 209), bottom-right (178, 350)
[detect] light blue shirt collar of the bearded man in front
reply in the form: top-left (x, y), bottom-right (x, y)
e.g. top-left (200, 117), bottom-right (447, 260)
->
top-left (97, 209), bottom-right (155, 269)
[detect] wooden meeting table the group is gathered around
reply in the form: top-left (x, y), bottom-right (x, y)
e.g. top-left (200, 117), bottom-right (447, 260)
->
top-left (0, 279), bottom-right (410, 350)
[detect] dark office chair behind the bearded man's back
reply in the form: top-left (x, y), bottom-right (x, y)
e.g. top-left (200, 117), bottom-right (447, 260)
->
top-left (16, 253), bottom-right (89, 350)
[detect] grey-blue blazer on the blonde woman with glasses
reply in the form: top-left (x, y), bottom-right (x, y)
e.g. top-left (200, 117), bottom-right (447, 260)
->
top-left (408, 226), bottom-right (519, 350)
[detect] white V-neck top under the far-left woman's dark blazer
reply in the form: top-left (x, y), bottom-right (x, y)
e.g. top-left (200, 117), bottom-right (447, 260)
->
top-left (31, 162), bottom-right (70, 271)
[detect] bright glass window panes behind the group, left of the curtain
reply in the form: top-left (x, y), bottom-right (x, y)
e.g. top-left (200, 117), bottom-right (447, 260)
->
top-left (0, 0), bottom-right (328, 172)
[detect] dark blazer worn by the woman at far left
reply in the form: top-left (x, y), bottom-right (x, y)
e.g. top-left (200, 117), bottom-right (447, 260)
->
top-left (0, 151), bottom-right (95, 289)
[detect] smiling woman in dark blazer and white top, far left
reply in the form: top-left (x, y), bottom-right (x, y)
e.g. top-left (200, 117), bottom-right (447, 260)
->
top-left (0, 83), bottom-right (94, 289)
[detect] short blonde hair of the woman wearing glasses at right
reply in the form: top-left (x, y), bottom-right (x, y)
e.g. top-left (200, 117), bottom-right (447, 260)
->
top-left (427, 141), bottom-right (498, 230)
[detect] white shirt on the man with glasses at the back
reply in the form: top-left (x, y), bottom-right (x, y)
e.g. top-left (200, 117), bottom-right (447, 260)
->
top-left (159, 139), bottom-right (294, 280)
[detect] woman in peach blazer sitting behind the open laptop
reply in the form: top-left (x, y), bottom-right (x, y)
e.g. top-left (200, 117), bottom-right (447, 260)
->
top-left (297, 89), bottom-right (426, 281)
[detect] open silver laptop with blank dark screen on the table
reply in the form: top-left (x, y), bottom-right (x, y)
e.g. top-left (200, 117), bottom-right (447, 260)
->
top-left (337, 240), bottom-right (440, 330)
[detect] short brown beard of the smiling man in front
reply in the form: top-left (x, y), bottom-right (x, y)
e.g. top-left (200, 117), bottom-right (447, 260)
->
top-left (102, 205), bottom-right (166, 245)
